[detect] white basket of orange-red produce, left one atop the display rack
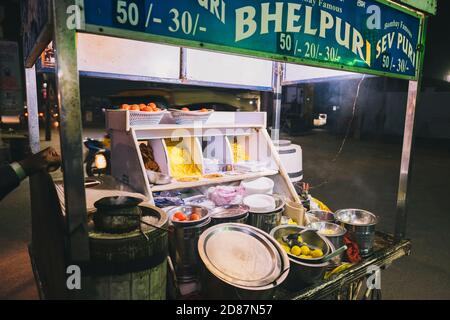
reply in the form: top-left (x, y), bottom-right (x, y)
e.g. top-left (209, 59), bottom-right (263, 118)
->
top-left (120, 102), bottom-right (167, 126)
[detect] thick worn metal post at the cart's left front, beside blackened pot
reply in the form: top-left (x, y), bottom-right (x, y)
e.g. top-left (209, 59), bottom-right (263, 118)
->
top-left (53, 0), bottom-right (89, 262)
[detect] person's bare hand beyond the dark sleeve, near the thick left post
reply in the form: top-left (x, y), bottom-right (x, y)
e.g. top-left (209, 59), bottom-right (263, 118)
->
top-left (19, 147), bottom-right (61, 176)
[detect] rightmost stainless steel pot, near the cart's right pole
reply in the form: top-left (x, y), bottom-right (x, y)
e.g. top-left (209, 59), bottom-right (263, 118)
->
top-left (335, 209), bottom-right (378, 257)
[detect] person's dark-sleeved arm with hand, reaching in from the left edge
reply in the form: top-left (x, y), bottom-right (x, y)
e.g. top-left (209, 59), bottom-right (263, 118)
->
top-left (0, 148), bottom-right (61, 201)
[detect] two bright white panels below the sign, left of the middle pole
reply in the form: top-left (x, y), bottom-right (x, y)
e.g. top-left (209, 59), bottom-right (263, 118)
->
top-left (77, 34), bottom-right (272, 91)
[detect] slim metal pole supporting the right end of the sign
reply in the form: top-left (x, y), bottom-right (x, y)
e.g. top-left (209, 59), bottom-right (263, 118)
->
top-left (395, 81), bottom-right (420, 241)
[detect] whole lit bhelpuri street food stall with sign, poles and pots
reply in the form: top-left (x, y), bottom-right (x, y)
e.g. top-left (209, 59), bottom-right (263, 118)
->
top-left (23, 0), bottom-right (436, 299)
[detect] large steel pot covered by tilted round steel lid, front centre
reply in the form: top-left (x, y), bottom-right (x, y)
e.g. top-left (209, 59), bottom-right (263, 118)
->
top-left (198, 223), bottom-right (289, 300)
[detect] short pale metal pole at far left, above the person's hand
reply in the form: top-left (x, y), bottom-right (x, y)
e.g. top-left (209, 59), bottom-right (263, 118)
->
top-left (25, 65), bottom-right (41, 153)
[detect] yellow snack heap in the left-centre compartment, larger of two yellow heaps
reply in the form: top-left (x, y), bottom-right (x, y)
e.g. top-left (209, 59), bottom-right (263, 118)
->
top-left (166, 140), bottom-right (202, 179)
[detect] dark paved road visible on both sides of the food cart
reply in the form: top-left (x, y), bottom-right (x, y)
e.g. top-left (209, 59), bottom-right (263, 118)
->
top-left (0, 132), bottom-right (450, 299)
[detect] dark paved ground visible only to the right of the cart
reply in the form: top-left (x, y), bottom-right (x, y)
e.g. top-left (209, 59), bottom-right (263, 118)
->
top-left (293, 132), bottom-right (450, 299)
